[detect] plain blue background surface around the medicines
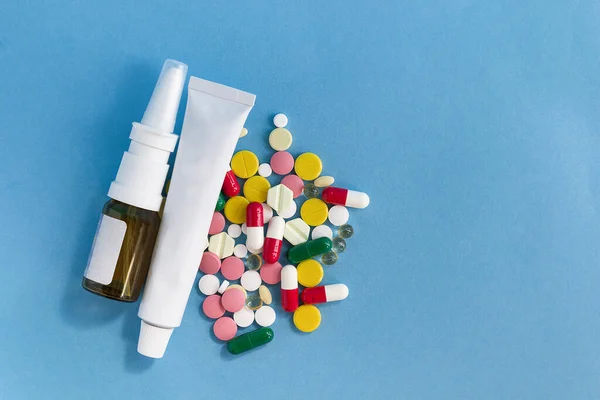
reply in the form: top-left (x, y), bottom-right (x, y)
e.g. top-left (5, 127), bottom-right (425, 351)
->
top-left (0, 0), bottom-right (600, 399)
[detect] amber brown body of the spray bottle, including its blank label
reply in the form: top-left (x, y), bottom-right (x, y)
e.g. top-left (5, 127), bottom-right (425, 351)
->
top-left (82, 199), bottom-right (160, 302)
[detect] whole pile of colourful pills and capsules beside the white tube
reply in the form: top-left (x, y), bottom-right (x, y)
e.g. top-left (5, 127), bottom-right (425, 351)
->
top-left (198, 114), bottom-right (369, 354)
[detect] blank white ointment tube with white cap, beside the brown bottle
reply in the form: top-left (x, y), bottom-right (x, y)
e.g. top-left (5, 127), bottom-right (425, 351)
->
top-left (138, 77), bottom-right (256, 358)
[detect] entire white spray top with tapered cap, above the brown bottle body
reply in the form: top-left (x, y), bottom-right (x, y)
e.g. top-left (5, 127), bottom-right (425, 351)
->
top-left (108, 60), bottom-right (187, 211)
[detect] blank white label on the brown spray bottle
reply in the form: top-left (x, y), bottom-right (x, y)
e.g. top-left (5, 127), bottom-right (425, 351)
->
top-left (84, 215), bottom-right (127, 285)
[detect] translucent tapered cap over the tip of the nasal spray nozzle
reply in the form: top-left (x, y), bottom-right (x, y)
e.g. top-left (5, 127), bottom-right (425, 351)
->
top-left (142, 60), bottom-right (187, 133)
